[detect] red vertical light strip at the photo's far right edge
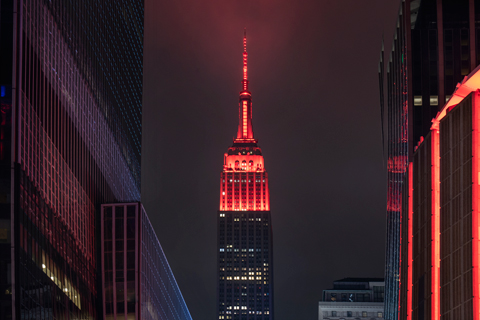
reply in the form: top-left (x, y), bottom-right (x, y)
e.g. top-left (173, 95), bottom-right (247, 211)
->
top-left (472, 91), bottom-right (480, 320)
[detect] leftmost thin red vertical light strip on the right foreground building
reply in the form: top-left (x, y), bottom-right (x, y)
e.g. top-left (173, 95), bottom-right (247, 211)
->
top-left (407, 162), bottom-right (413, 320)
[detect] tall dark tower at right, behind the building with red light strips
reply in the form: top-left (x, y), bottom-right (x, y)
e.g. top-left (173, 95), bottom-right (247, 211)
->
top-left (379, 0), bottom-right (480, 319)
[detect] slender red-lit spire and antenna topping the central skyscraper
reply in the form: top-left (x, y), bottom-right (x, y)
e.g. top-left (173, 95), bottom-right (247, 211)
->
top-left (235, 28), bottom-right (254, 142)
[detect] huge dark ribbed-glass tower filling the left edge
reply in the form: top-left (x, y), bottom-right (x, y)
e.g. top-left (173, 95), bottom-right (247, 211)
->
top-left (0, 0), bottom-right (144, 319)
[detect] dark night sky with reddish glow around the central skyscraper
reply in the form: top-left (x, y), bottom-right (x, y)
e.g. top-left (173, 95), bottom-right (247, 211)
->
top-left (142, 0), bottom-right (400, 320)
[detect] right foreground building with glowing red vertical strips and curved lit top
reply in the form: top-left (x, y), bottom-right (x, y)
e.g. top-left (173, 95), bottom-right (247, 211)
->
top-left (399, 67), bottom-right (480, 320)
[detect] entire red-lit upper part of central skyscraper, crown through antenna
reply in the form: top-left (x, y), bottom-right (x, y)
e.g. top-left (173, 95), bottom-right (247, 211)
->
top-left (220, 30), bottom-right (270, 211)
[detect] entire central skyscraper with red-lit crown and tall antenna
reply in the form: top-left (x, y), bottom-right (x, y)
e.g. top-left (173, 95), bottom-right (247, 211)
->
top-left (217, 31), bottom-right (273, 320)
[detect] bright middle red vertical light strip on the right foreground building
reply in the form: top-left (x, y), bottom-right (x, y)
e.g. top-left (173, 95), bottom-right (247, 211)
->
top-left (430, 120), bottom-right (440, 320)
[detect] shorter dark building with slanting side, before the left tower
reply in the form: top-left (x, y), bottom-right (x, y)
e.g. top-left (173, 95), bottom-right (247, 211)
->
top-left (101, 202), bottom-right (192, 320)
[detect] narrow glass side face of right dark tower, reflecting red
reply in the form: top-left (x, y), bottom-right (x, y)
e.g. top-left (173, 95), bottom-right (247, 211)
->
top-left (380, 6), bottom-right (408, 319)
